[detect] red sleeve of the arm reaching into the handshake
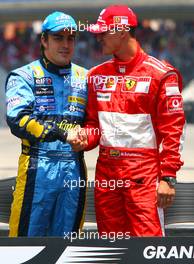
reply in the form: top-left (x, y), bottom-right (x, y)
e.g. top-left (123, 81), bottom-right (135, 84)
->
top-left (84, 74), bottom-right (100, 151)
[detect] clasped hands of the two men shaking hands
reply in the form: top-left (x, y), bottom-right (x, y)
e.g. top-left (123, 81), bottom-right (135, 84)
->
top-left (66, 125), bottom-right (88, 152)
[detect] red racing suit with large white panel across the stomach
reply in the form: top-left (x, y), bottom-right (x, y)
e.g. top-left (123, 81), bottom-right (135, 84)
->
top-left (85, 43), bottom-right (185, 236)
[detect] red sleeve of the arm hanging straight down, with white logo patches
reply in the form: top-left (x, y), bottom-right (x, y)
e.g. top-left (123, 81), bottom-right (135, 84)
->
top-left (157, 71), bottom-right (185, 178)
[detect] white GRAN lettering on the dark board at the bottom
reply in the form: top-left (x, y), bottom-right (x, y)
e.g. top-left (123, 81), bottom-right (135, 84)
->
top-left (143, 246), bottom-right (194, 259)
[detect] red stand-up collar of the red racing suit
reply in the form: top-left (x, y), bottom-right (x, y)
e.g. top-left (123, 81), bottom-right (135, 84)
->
top-left (113, 43), bottom-right (146, 74)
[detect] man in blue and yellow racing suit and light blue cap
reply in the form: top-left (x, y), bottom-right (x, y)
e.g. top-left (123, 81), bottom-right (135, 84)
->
top-left (6, 12), bottom-right (87, 237)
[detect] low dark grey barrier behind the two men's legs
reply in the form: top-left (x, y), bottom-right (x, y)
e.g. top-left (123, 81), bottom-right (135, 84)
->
top-left (0, 177), bottom-right (194, 236)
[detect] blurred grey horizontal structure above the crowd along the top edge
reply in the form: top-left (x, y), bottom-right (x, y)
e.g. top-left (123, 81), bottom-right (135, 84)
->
top-left (0, 0), bottom-right (194, 22)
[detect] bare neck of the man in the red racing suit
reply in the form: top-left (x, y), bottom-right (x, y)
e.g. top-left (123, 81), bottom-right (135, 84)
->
top-left (114, 38), bottom-right (138, 62)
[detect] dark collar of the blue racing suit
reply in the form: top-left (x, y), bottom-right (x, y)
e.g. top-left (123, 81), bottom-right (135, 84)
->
top-left (40, 56), bottom-right (72, 75)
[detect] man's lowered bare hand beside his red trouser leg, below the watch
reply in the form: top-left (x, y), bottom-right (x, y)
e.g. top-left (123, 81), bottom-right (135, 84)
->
top-left (157, 180), bottom-right (176, 208)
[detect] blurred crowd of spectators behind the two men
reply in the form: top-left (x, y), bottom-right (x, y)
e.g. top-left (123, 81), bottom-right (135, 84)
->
top-left (0, 20), bottom-right (194, 85)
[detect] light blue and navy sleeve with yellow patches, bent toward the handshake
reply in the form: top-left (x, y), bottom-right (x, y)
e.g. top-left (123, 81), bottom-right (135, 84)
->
top-left (6, 73), bottom-right (66, 142)
